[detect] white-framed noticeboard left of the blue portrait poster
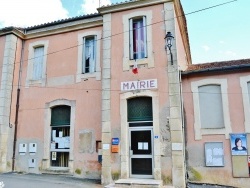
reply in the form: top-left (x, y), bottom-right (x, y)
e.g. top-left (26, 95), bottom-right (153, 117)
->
top-left (205, 142), bottom-right (224, 166)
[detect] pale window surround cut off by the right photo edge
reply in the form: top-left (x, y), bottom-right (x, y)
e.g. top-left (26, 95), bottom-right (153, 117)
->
top-left (240, 75), bottom-right (250, 133)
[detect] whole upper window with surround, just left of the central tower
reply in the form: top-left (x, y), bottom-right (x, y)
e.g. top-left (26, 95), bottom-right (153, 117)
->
top-left (76, 31), bottom-right (101, 82)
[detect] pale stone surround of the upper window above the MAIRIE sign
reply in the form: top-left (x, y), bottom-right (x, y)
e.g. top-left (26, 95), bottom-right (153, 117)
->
top-left (123, 10), bottom-right (154, 71)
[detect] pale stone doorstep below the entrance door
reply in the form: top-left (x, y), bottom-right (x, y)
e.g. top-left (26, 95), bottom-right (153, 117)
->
top-left (106, 179), bottom-right (162, 188)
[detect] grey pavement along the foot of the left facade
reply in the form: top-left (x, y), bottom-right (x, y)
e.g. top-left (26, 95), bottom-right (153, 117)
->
top-left (0, 173), bottom-right (103, 188)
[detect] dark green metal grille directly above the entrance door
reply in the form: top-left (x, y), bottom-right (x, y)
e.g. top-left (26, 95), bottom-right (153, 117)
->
top-left (127, 97), bottom-right (153, 122)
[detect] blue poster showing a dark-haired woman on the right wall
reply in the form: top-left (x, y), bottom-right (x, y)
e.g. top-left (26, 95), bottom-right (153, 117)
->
top-left (230, 133), bottom-right (247, 155)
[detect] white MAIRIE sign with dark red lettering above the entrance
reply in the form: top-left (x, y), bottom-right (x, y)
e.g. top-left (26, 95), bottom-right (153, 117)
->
top-left (121, 79), bottom-right (157, 91)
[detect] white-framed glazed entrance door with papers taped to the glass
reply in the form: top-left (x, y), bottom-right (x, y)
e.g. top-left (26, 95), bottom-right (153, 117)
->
top-left (129, 127), bottom-right (153, 178)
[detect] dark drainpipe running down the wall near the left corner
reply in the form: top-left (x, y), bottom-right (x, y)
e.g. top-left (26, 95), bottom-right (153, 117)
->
top-left (12, 37), bottom-right (25, 172)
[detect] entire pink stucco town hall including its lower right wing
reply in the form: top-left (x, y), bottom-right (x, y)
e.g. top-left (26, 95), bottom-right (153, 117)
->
top-left (0, 0), bottom-right (250, 187)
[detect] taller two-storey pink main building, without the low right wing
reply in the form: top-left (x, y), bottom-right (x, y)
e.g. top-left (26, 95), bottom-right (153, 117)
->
top-left (0, 0), bottom-right (191, 187)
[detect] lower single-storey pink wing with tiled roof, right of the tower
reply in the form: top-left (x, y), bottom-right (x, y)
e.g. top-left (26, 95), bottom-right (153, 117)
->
top-left (182, 59), bottom-right (250, 188)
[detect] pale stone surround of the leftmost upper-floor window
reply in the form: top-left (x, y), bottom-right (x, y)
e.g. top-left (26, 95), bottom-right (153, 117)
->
top-left (26, 40), bottom-right (49, 87)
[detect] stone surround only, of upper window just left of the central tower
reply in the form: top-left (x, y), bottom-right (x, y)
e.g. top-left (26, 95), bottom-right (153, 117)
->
top-left (76, 31), bottom-right (101, 82)
